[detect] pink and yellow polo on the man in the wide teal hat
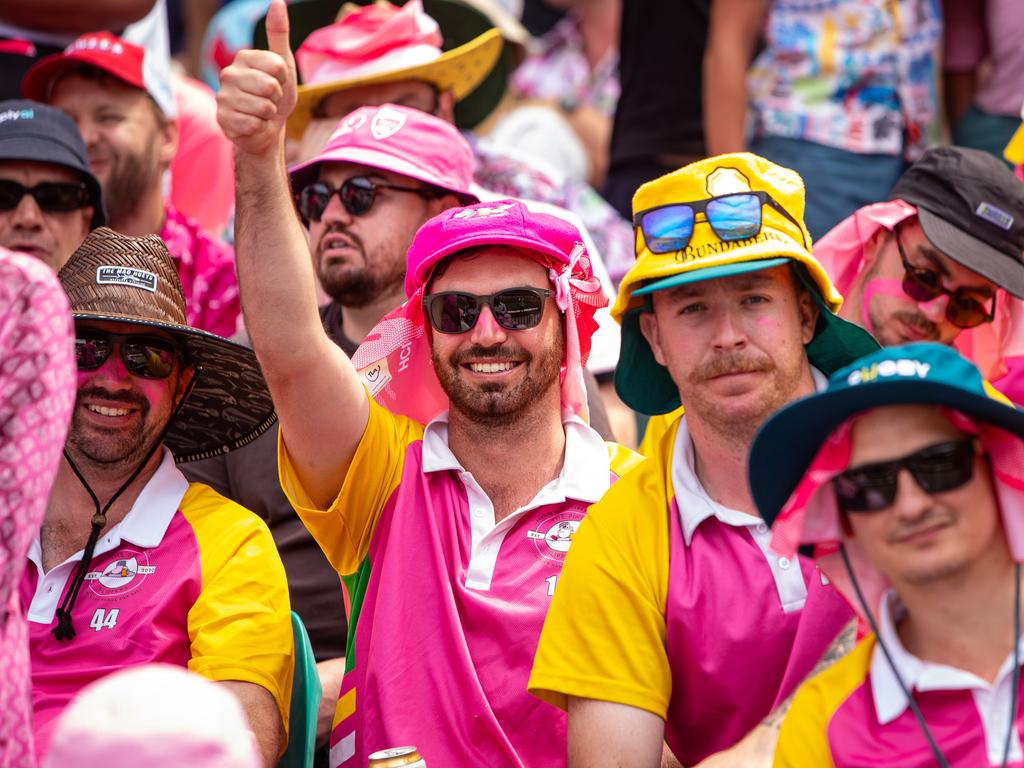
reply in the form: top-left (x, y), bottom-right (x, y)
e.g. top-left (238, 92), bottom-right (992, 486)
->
top-left (774, 591), bottom-right (1024, 768)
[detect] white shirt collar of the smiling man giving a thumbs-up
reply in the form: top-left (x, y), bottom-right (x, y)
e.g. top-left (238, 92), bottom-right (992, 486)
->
top-left (423, 412), bottom-right (611, 509)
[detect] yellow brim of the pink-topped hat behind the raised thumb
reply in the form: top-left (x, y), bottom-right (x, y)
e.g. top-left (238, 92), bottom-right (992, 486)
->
top-left (287, 29), bottom-right (504, 139)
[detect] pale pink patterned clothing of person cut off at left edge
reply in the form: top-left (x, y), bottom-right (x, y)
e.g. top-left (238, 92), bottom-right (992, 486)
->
top-left (0, 249), bottom-right (75, 768)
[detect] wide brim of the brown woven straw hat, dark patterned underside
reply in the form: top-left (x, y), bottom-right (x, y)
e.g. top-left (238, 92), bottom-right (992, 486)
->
top-left (72, 312), bottom-right (278, 464)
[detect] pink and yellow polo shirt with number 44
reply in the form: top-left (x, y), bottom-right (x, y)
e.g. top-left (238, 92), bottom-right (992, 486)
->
top-left (20, 451), bottom-right (294, 755)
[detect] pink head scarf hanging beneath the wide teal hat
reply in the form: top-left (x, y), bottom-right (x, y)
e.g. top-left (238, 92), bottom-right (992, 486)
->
top-left (771, 408), bottom-right (1024, 614)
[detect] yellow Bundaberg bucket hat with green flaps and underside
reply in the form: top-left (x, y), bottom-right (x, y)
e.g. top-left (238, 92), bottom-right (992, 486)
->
top-left (611, 153), bottom-right (879, 415)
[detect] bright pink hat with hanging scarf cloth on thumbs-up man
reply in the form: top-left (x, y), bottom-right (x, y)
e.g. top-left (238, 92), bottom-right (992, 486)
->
top-left (352, 200), bottom-right (608, 424)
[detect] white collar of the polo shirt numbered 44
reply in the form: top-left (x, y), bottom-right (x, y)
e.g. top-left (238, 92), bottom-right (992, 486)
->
top-left (29, 449), bottom-right (188, 565)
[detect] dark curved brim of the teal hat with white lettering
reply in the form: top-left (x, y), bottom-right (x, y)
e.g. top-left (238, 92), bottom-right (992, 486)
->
top-left (750, 379), bottom-right (1024, 525)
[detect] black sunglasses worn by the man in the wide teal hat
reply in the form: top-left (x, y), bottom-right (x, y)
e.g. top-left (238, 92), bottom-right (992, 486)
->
top-left (833, 438), bottom-right (978, 512)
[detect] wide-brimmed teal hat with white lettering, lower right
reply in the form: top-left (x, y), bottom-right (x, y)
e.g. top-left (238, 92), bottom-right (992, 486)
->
top-left (750, 342), bottom-right (1024, 525)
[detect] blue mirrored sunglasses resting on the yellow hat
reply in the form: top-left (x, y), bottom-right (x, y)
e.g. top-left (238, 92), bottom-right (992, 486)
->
top-left (633, 191), bottom-right (810, 253)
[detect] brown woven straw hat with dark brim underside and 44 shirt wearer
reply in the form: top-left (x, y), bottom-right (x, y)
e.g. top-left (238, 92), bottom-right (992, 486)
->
top-left (57, 227), bottom-right (278, 464)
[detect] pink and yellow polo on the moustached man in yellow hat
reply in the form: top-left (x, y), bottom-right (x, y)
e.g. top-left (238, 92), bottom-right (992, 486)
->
top-left (529, 417), bottom-right (853, 765)
